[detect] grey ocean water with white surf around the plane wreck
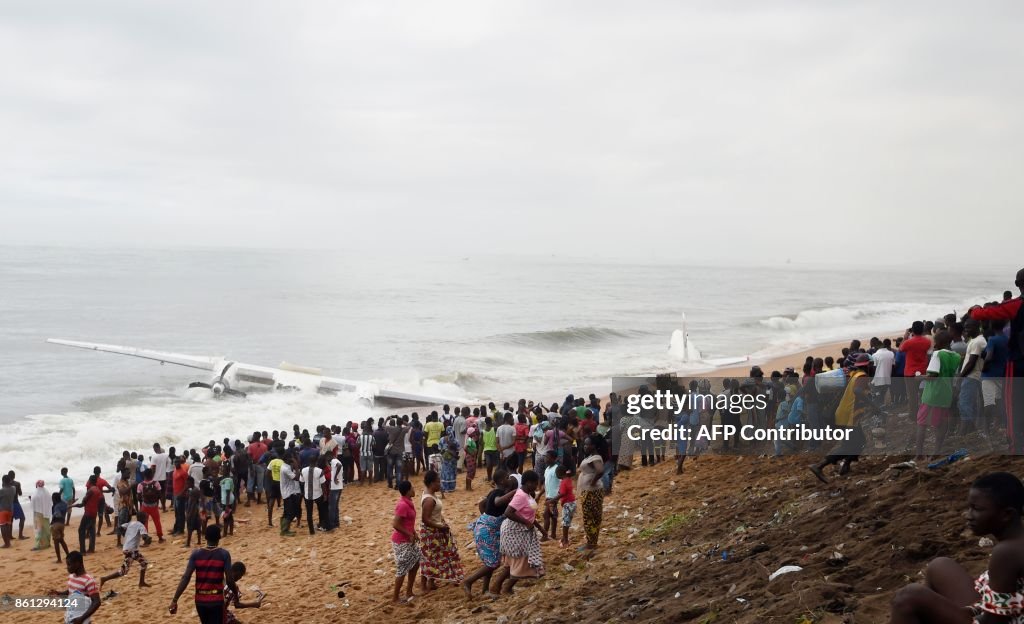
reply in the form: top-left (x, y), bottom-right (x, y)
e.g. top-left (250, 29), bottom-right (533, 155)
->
top-left (0, 247), bottom-right (1014, 486)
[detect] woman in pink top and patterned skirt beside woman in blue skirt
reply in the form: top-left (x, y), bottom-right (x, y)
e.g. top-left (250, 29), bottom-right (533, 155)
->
top-left (500, 470), bottom-right (548, 593)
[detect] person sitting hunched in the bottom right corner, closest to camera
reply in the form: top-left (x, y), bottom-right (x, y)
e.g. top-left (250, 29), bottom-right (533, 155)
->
top-left (890, 472), bottom-right (1024, 624)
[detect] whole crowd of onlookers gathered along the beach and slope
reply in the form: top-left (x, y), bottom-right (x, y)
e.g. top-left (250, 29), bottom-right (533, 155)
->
top-left (0, 264), bottom-right (1024, 622)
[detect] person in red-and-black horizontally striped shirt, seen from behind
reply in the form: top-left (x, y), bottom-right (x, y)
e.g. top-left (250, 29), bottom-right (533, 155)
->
top-left (168, 525), bottom-right (239, 624)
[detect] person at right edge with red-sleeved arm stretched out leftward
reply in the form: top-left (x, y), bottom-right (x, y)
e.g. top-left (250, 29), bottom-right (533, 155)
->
top-left (969, 268), bottom-right (1024, 455)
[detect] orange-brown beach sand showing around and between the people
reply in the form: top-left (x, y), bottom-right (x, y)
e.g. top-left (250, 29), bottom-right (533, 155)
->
top-left (3, 327), bottom-right (937, 624)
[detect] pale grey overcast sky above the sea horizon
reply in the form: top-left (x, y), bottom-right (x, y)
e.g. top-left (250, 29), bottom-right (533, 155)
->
top-left (0, 0), bottom-right (1024, 266)
